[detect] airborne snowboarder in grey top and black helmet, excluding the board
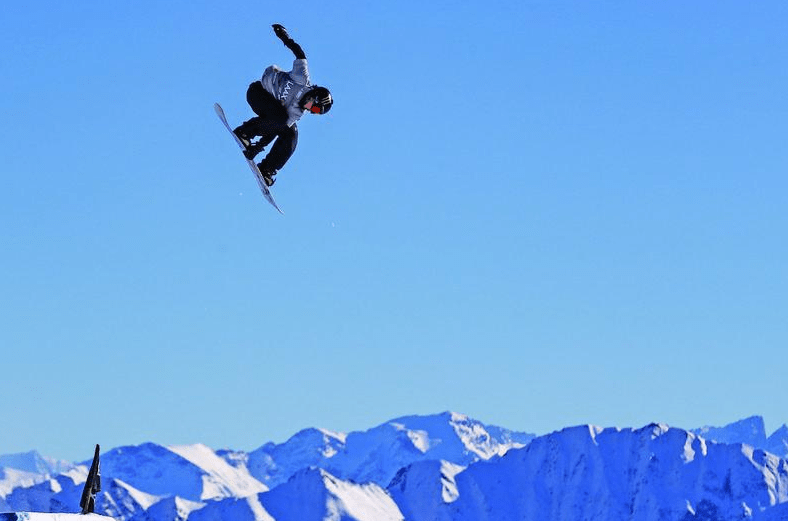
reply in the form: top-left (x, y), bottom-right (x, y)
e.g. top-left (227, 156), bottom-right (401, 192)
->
top-left (234, 24), bottom-right (334, 186)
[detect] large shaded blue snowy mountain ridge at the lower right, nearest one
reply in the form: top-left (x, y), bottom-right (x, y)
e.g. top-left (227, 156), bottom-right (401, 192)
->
top-left (390, 425), bottom-right (788, 521)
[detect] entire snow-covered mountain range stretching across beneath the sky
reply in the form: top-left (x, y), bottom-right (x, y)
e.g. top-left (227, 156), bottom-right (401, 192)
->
top-left (0, 413), bottom-right (788, 521)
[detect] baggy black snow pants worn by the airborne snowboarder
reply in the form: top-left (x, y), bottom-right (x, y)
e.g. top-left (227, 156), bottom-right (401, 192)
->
top-left (236, 81), bottom-right (298, 172)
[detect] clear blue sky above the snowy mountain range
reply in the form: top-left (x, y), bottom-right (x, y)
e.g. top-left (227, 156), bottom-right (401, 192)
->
top-left (0, 0), bottom-right (788, 459)
